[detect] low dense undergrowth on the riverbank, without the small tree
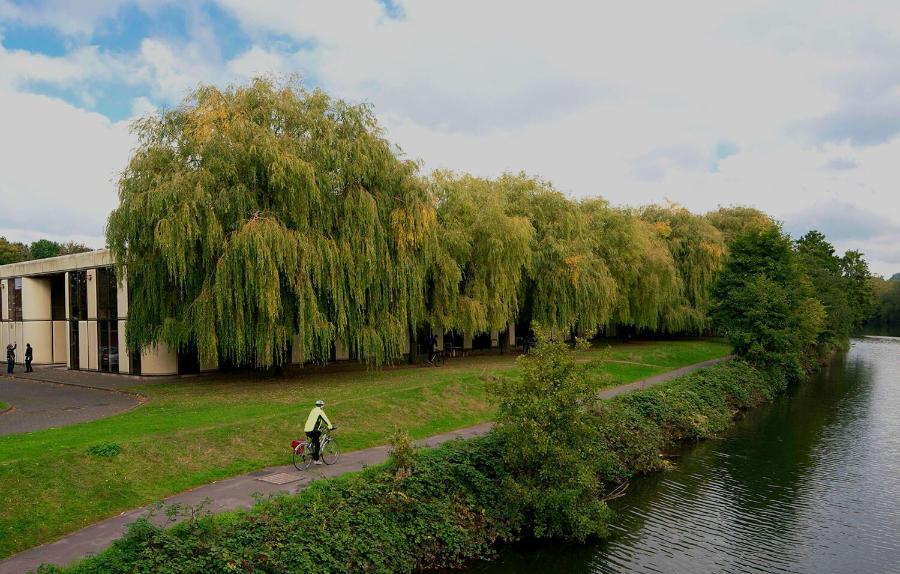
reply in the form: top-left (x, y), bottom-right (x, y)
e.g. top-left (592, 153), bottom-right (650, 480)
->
top-left (38, 361), bottom-right (783, 573)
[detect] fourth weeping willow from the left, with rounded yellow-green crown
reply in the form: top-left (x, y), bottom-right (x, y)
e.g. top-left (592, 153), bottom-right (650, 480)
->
top-left (580, 198), bottom-right (680, 331)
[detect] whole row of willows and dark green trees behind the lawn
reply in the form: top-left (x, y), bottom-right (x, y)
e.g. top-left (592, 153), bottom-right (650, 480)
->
top-left (107, 79), bottom-right (869, 366)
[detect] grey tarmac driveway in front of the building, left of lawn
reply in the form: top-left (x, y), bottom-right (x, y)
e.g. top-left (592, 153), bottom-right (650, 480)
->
top-left (0, 376), bottom-right (141, 435)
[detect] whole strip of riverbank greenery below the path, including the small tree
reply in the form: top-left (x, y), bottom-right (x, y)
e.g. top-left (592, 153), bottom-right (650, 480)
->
top-left (54, 354), bottom-right (784, 574)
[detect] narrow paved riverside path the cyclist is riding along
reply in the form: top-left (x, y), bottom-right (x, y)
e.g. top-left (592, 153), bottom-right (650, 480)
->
top-left (0, 357), bottom-right (730, 574)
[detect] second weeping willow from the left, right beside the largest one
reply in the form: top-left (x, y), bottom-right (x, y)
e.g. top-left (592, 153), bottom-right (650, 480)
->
top-left (429, 171), bottom-right (534, 333)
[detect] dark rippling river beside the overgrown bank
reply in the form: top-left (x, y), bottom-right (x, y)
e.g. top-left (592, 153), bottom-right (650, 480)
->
top-left (471, 337), bottom-right (900, 574)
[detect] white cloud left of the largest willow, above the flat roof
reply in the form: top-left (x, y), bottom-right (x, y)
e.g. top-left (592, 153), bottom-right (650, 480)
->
top-left (0, 90), bottom-right (135, 247)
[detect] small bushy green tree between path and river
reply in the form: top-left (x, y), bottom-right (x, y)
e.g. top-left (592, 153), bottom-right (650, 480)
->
top-left (492, 333), bottom-right (610, 540)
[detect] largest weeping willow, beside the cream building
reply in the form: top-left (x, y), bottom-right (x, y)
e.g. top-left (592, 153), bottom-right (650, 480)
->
top-left (107, 79), bottom-right (435, 366)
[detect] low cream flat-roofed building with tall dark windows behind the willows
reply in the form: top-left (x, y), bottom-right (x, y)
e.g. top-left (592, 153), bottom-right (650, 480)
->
top-left (0, 249), bottom-right (516, 375)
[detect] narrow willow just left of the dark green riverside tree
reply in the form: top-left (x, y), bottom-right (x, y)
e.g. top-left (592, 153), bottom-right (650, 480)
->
top-left (640, 204), bottom-right (725, 331)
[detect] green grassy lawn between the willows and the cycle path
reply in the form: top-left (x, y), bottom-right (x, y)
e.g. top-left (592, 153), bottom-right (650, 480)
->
top-left (0, 341), bottom-right (730, 557)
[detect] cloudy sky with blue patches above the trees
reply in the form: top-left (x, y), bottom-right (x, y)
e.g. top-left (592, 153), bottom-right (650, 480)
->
top-left (0, 0), bottom-right (900, 276)
